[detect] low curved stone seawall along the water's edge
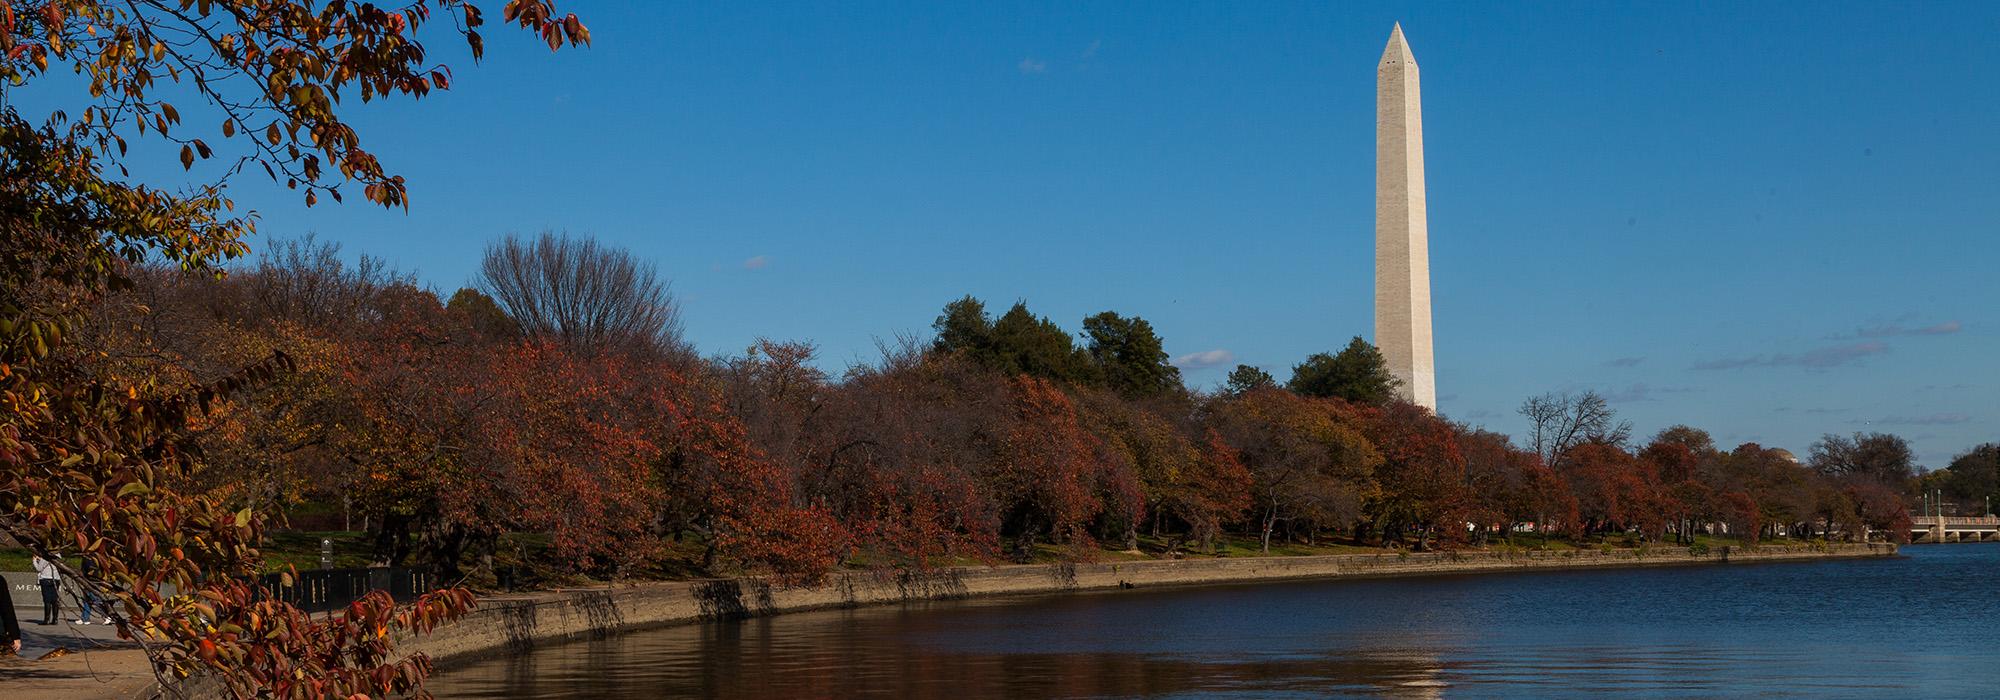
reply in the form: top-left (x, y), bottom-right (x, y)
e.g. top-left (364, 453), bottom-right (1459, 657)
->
top-left (410, 544), bottom-right (1896, 666)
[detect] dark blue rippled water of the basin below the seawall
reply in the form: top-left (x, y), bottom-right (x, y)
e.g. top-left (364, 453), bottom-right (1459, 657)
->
top-left (432, 544), bottom-right (2000, 700)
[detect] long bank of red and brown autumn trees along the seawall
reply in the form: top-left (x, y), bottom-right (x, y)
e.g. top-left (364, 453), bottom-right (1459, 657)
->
top-left (78, 234), bottom-right (1956, 596)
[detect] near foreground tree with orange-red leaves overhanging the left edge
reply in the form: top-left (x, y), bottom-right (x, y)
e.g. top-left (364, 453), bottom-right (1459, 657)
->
top-left (0, 0), bottom-right (588, 696)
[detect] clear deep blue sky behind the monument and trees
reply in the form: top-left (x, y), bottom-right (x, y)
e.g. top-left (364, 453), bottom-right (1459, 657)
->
top-left (35, 0), bottom-right (2000, 466)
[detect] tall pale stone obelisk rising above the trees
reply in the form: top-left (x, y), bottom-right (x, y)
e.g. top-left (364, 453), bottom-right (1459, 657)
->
top-left (1376, 22), bottom-right (1438, 410)
